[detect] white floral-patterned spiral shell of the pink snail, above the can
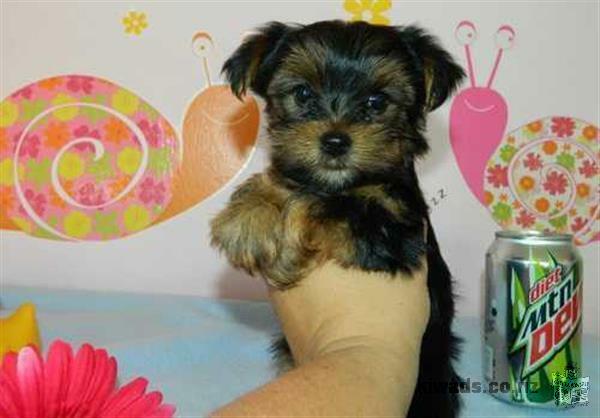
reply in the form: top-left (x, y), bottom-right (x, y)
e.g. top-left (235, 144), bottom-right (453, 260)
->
top-left (484, 116), bottom-right (600, 244)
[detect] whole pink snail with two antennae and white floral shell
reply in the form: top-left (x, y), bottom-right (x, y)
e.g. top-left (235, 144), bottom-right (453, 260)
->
top-left (450, 21), bottom-right (600, 244)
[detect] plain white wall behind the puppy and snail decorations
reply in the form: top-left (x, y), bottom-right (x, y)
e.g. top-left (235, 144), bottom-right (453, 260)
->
top-left (0, 0), bottom-right (600, 332)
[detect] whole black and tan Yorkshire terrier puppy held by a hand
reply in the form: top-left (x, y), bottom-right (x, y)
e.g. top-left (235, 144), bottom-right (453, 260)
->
top-left (212, 21), bottom-right (464, 418)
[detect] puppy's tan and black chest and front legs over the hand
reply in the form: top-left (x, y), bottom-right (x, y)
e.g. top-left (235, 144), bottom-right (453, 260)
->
top-left (212, 172), bottom-right (426, 288)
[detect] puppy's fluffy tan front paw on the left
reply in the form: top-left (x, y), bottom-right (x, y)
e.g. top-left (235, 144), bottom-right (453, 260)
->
top-left (211, 174), bottom-right (289, 275)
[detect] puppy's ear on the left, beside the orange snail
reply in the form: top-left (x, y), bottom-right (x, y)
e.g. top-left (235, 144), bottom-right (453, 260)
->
top-left (221, 22), bottom-right (294, 97)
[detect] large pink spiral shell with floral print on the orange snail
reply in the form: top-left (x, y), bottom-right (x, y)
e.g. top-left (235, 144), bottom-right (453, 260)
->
top-left (0, 75), bottom-right (179, 241)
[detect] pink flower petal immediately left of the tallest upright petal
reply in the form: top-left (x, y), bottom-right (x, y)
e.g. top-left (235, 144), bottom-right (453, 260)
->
top-left (17, 346), bottom-right (44, 417)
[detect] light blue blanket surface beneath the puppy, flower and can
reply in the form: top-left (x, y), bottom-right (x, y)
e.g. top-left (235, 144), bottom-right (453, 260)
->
top-left (0, 287), bottom-right (600, 417)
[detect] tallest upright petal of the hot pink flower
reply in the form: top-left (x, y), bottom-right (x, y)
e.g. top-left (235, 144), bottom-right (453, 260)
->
top-left (44, 340), bottom-right (73, 418)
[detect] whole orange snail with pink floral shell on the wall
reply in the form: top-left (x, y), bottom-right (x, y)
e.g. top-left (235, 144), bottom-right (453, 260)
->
top-left (0, 33), bottom-right (259, 241)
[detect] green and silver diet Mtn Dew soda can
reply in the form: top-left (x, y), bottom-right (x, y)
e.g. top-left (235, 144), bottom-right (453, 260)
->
top-left (483, 231), bottom-right (583, 407)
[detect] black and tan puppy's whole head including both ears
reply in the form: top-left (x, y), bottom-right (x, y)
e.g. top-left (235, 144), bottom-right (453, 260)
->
top-left (224, 21), bottom-right (463, 192)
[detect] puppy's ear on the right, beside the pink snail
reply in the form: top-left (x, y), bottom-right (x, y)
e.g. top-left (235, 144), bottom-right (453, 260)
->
top-left (399, 26), bottom-right (465, 111)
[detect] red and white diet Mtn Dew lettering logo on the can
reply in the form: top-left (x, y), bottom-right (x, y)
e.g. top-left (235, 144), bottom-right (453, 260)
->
top-left (510, 260), bottom-right (581, 379)
